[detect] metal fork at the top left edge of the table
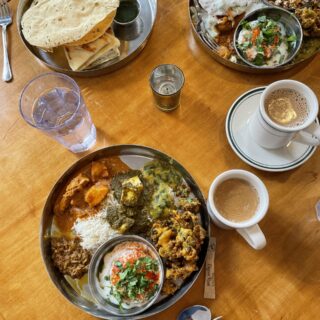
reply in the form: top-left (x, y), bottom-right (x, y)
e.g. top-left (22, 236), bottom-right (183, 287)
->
top-left (0, 0), bottom-right (12, 81)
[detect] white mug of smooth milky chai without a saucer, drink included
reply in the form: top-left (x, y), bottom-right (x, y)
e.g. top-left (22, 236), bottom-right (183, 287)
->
top-left (207, 170), bottom-right (269, 250)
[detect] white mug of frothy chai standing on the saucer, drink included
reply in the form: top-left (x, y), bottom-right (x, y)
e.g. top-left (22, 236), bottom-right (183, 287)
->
top-left (249, 80), bottom-right (320, 149)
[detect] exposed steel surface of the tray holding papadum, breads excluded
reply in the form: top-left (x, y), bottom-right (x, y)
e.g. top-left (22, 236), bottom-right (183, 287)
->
top-left (17, 0), bottom-right (157, 77)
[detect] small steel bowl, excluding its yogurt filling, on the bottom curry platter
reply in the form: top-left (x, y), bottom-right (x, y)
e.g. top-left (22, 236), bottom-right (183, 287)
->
top-left (88, 235), bottom-right (164, 317)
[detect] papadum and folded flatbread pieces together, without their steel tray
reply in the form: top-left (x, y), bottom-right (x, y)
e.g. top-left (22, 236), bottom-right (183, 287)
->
top-left (21, 0), bottom-right (120, 71)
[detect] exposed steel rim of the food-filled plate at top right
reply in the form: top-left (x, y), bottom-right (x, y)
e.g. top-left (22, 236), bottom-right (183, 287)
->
top-left (189, 0), bottom-right (320, 74)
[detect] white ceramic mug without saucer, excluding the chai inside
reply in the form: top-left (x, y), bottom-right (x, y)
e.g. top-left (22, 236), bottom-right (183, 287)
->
top-left (207, 170), bottom-right (269, 250)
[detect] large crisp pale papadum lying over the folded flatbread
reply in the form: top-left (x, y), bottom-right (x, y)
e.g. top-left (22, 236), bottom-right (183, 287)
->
top-left (21, 0), bottom-right (119, 48)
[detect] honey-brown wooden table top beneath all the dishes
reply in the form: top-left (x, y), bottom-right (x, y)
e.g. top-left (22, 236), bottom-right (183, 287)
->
top-left (0, 0), bottom-right (320, 320)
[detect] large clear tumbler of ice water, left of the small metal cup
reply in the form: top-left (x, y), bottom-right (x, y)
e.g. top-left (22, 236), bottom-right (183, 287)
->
top-left (19, 72), bottom-right (96, 152)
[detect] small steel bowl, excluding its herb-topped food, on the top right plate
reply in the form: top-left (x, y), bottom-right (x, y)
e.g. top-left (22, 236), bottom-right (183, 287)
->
top-left (233, 7), bottom-right (303, 69)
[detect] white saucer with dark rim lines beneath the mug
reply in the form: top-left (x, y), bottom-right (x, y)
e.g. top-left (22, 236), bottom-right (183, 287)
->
top-left (226, 87), bottom-right (316, 172)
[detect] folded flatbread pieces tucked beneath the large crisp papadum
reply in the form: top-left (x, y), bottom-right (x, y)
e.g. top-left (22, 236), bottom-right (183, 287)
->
top-left (64, 33), bottom-right (120, 71)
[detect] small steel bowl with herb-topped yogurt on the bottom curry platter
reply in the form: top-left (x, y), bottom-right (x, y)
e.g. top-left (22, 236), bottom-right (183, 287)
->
top-left (89, 235), bottom-right (164, 317)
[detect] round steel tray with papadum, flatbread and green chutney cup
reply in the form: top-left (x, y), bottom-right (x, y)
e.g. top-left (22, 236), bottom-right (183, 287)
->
top-left (17, 0), bottom-right (157, 76)
